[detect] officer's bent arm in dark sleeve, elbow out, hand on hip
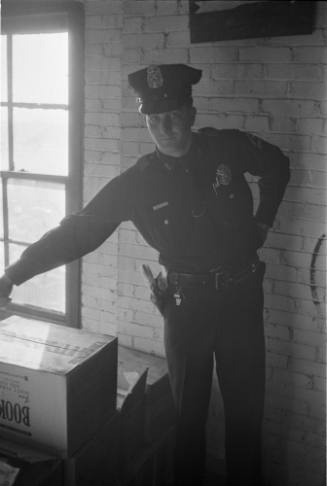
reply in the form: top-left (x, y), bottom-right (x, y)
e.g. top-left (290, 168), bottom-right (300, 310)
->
top-left (238, 132), bottom-right (290, 235)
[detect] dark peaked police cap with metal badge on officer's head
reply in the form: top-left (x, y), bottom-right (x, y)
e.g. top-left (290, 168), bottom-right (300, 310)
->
top-left (128, 64), bottom-right (202, 115)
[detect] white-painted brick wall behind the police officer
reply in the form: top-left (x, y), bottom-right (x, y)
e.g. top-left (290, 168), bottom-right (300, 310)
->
top-left (82, 0), bottom-right (327, 486)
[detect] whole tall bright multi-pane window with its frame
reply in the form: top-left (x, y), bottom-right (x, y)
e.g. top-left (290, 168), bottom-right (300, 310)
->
top-left (0, 0), bottom-right (83, 326)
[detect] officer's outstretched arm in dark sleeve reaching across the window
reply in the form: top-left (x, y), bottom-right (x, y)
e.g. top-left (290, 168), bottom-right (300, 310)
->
top-left (0, 169), bottom-right (135, 292)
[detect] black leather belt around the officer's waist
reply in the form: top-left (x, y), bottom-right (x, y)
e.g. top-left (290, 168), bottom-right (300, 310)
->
top-left (168, 259), bottom-right (262, 290)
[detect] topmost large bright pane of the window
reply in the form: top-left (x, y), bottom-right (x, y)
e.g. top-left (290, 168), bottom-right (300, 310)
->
top-left (13, 32), bottom-right (68, 104)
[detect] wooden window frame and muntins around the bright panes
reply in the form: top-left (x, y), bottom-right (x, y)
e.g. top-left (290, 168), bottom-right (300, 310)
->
top-left (0, 0), bottom-right (84, 327)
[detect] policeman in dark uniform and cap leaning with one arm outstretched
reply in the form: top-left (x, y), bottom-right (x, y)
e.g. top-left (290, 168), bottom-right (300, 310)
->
top-left (0, 64), bottom-right (289, 486)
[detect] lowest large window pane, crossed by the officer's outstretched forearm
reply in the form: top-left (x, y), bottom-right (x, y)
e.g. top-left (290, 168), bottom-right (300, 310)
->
top-left (9, 245), bottom-right (66, 313)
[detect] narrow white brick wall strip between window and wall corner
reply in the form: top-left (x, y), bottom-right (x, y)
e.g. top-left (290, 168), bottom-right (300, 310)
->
top-left (81, 0), bottom-right (123, 335)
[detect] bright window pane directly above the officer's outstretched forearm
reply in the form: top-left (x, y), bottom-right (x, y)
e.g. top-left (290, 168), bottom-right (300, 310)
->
top-left (8, 179), bottom-right (65, 243)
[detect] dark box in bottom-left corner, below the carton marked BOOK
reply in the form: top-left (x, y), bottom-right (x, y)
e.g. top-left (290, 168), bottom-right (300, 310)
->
top-left (0, 439), bottom-right (63, 486)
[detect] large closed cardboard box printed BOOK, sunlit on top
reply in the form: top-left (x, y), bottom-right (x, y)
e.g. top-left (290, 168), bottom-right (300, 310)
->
top-left (0, 316), bottom-right (117, 456)
